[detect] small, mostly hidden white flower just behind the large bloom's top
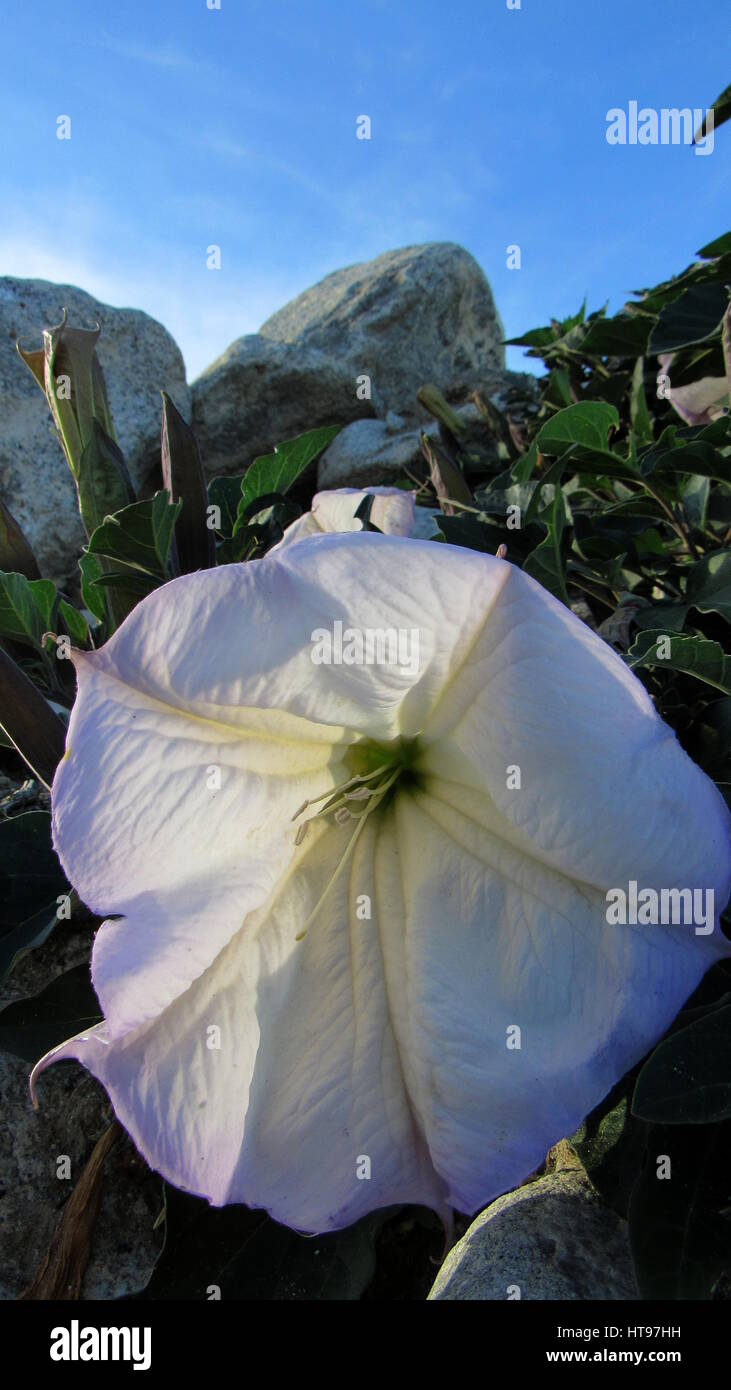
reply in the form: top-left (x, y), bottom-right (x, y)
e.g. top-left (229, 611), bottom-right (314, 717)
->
top-left (270, 488), bottom-right (436, 555)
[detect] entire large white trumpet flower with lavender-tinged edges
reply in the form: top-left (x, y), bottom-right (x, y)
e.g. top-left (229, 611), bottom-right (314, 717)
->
top-left (35, 534), bottom-right (731, 1232)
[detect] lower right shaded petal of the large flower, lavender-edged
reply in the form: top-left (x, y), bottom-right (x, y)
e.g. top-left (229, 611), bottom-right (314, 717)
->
top-left (389, 781), bottom-right (727, 1212)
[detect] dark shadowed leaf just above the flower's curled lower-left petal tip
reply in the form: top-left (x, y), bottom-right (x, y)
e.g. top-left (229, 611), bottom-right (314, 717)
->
top-left (0, 965), bottom-right (101, 1063)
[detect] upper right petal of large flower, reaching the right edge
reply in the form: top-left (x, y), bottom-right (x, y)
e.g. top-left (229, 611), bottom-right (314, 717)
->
top-left (422, 567), bottom-right (731, 909)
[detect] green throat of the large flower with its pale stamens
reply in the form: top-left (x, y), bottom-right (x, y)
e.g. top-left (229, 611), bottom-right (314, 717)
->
top-left (292, 738), bottom-right (417, 941)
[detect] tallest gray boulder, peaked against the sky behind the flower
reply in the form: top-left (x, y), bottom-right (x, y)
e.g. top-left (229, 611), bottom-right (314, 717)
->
top-left (260, 242), bottom-right (504, 421)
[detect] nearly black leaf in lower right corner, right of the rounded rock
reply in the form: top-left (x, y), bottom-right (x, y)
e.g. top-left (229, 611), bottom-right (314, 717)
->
top-left (628, 1120), bottom-right (731, 1301)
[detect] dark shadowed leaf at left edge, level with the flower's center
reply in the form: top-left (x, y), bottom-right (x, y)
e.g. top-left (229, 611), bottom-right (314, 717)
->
top-left (0, 810), bottom-right (68, 981)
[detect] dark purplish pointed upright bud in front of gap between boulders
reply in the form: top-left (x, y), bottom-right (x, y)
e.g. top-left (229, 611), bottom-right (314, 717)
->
top-left (161, 392), bottom-right (215, 574)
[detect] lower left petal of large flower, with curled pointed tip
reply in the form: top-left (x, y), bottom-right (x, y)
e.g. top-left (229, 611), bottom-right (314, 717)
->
top-left (33, 824), bottom-right (453, 1232)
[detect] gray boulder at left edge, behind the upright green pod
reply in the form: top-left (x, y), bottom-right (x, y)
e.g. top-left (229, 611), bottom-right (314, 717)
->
top-left (0, 277), bottom-right (190, 581)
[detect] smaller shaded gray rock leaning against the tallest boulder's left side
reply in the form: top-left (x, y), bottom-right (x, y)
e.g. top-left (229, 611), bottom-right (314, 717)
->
top-left (193, 334), bottom-right (374, 478)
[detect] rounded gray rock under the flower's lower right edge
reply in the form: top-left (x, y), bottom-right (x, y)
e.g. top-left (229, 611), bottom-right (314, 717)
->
top-left (428, 1168), bottom-right (639, 1301)
